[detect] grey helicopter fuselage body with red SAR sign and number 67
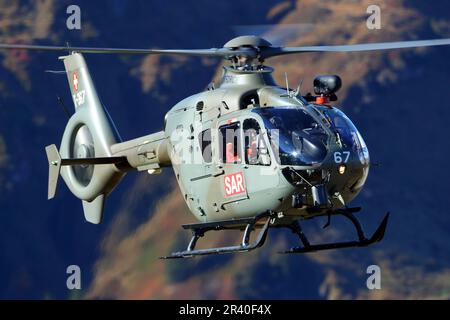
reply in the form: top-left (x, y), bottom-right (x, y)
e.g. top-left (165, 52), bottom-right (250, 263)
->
top-left (160, 67), bottom-right (369, 222)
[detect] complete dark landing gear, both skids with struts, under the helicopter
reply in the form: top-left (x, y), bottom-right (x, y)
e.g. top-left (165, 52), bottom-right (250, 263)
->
top-left (161, 208), bottom-right (389, 259)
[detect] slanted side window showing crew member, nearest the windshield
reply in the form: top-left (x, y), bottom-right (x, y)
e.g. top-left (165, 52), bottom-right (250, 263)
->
top-left (244, 119), bottom-right (270, 166)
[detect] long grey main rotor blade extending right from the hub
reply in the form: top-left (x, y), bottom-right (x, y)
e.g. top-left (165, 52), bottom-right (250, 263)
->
top-left (261, 39), bottom-right (450, 59)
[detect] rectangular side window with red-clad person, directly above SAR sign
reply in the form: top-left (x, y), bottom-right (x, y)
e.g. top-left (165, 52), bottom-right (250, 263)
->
top-left (219, 122), bottom-right (242, 164)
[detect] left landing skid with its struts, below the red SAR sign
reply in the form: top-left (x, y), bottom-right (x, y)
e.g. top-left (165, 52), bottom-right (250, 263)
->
top-left (161, 213), bottom-right (271, 259)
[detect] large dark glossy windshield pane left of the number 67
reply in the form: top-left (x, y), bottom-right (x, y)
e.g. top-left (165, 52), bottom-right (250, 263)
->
top-left (254, 107), bottom-right (329, 165)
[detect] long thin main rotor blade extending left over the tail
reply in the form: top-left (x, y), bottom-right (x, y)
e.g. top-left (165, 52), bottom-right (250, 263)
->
top-left (0, 44), bottom-right (256, 58)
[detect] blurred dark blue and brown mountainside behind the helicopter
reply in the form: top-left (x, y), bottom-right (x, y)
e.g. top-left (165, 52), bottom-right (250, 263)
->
top-left (0, 0), bottom-right (450, 299)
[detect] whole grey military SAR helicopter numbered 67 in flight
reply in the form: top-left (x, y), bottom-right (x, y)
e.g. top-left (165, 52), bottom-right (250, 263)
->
top-left (0, 36), bottom-right (450, 258)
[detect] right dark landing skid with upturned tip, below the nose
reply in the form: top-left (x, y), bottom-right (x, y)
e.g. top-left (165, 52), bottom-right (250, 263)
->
top-left (281, 209), bottom-right (389, 253)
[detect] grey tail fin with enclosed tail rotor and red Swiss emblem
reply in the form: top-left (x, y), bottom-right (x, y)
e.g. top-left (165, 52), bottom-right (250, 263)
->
top-left (46, 53), bottom-right (124, 223)
